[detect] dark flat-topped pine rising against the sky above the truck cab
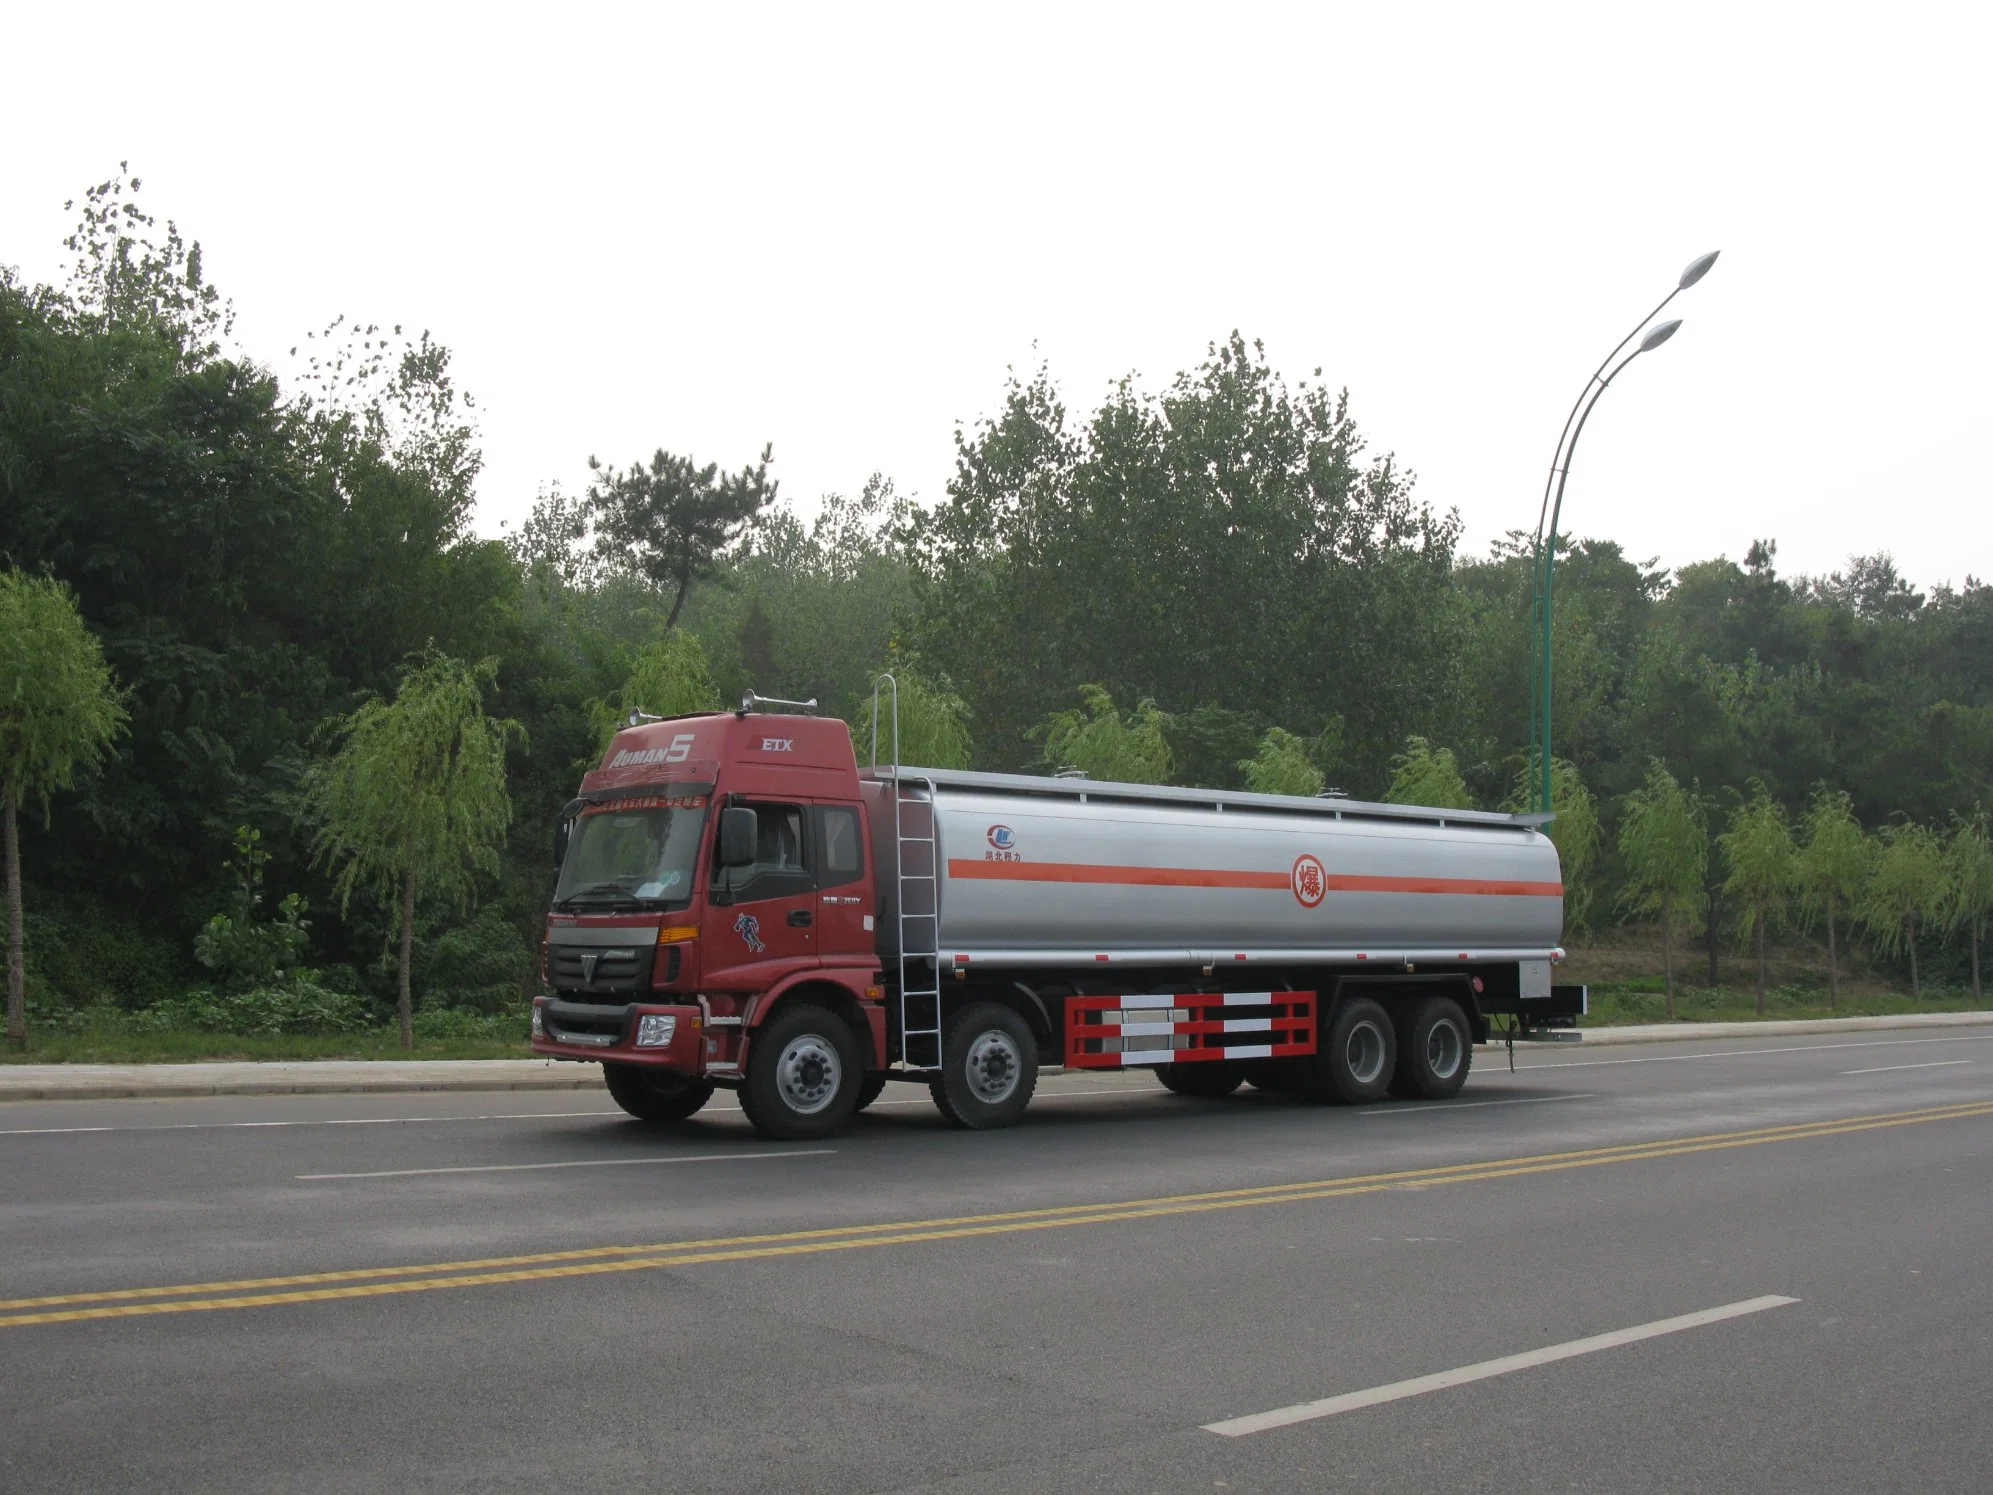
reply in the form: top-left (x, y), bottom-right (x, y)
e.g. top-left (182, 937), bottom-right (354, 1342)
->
top-left (588, 447), bottom-right (775, 632)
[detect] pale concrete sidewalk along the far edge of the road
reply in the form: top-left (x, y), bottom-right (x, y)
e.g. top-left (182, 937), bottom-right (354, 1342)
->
top-left (0, 1013), bottom-right (1993, 1100)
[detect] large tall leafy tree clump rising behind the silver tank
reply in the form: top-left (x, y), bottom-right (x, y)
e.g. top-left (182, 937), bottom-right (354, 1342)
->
top-left (907, 335), bottom-right (1458, 787)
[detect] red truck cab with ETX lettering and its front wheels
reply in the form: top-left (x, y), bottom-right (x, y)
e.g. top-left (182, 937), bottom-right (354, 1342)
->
top-left (532, 710), bottom-right (887, 1136)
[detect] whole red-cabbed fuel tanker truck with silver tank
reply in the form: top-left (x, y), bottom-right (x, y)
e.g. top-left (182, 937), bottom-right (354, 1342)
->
top-left (532, 696), bottom-right (1584, 1138)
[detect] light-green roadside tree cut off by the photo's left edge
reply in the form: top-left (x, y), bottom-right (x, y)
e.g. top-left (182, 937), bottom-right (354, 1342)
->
top-left (0, 568), bottom-right (126, 1048)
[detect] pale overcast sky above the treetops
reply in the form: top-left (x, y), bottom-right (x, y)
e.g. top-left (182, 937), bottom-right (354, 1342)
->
top-left (0, 0), bottom-right (1993, 584)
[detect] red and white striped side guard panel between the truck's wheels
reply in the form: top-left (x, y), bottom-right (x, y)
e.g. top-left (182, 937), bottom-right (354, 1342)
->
top-left (1066, 991), bottom-right (1315, 1068)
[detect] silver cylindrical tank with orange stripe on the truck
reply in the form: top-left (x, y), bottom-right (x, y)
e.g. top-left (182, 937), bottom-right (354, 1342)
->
top-left (867, 767), bottom-right (1563, 967)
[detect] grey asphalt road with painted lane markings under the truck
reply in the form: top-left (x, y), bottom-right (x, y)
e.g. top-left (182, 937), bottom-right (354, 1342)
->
top-left (0, 1029), bottom-right (1993, 1495)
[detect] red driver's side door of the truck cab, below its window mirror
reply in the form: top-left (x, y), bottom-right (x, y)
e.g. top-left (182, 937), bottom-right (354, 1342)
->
top-left (702, 799), bottom-right (817, 991)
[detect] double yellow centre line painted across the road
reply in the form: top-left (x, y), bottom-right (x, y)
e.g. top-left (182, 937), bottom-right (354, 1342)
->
top-left (0, 1100), bottom-right (1993, 1328)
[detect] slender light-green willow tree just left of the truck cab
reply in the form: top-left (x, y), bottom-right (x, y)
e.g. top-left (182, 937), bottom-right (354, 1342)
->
top-left (305, 650), bottom-right (522, 1048)
